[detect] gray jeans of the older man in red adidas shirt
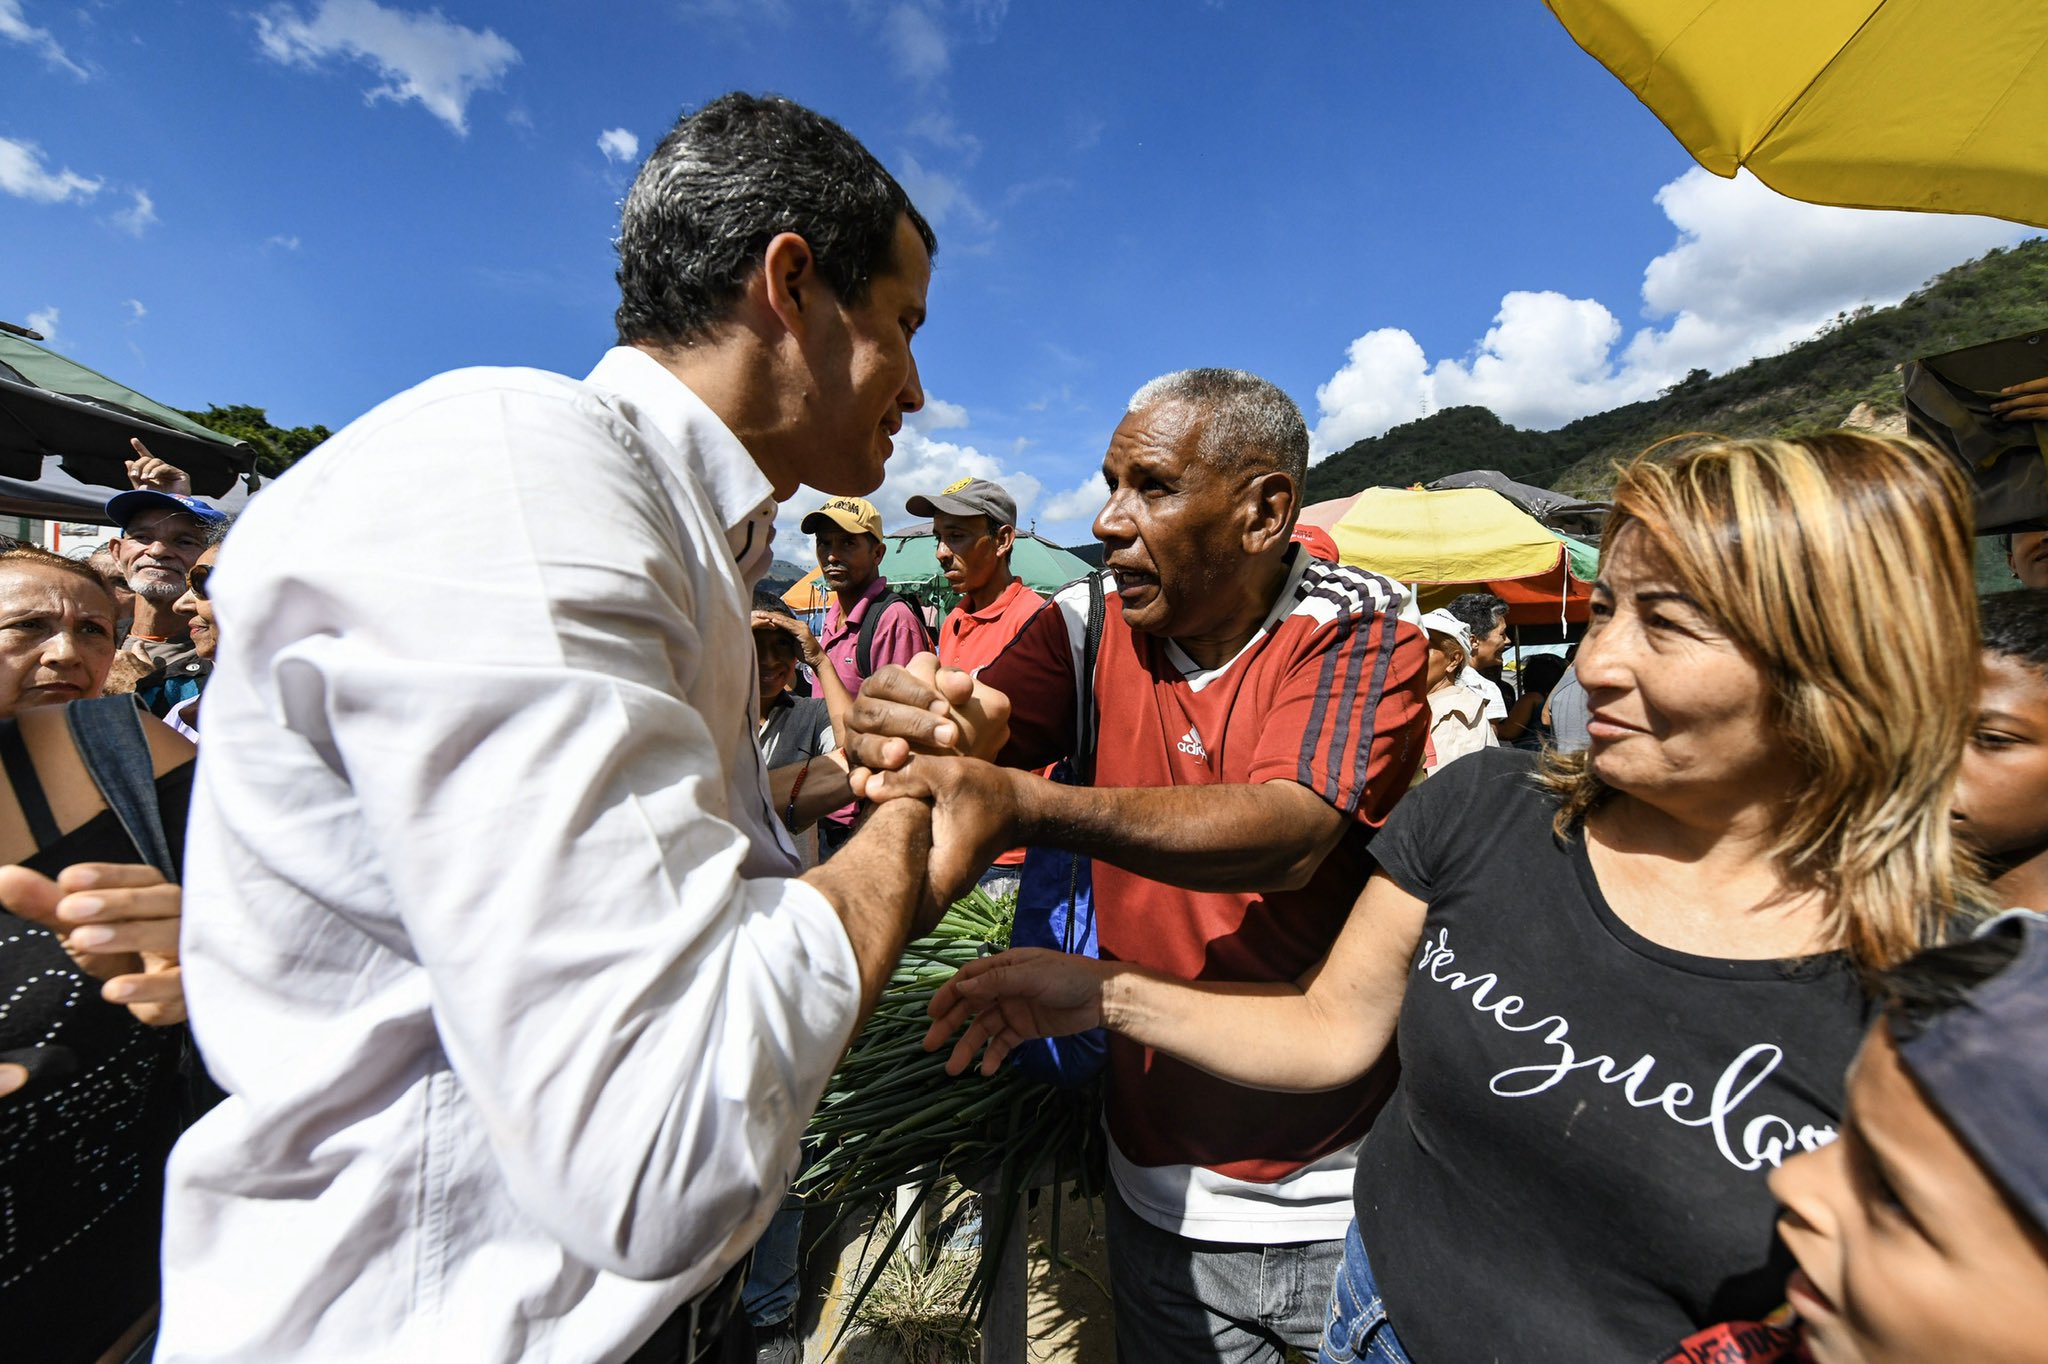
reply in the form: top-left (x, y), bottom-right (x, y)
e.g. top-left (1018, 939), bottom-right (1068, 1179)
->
top-left (1104, 1184), bottom-right (1343, 1364)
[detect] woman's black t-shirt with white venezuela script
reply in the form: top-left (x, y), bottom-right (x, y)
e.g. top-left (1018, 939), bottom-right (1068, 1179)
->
top-left (1356, 748), bottom-right (1870, 1364)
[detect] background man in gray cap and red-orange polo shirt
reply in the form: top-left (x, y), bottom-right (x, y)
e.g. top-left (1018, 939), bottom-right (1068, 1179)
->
top-left (903, 479), bottom-right (1044, 672)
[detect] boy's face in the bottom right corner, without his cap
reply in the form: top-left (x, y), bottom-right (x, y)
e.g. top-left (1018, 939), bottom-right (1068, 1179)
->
top-left (1772, 1020), bottom-right (2048, 1364)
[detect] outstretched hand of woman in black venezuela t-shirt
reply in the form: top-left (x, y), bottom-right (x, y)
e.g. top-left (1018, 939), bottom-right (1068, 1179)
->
top-left (924, 948), bottom-right (1122, 1075)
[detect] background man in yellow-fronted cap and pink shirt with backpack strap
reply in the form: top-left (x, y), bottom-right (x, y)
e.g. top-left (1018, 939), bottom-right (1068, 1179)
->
top-left (797, 498), bottom-right (932, 860)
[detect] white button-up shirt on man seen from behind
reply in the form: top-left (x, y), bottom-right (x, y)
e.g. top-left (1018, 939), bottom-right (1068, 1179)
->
top-left (158, 350), bottom-right (860, 1364)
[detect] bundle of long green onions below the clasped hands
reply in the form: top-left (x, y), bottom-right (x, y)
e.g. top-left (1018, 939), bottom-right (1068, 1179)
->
top-left (795, 891), bottom-right (1102, 1317)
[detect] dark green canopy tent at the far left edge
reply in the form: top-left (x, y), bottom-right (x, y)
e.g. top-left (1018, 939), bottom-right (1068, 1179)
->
top-left (0, 334), bottom-right (256, 503)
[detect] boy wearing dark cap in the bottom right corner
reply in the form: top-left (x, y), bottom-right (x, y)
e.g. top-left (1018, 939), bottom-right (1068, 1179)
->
top-left (1772, 909), bottom-right (2048, 1364)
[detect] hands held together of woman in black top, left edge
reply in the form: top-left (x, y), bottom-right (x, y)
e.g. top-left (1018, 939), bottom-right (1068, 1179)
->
top-left (0, 862), bottom-right (184, 1028)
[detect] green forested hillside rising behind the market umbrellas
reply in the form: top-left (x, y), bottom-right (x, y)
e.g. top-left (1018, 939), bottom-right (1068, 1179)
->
top-left (1309, 240), bottom-right (2048, 502)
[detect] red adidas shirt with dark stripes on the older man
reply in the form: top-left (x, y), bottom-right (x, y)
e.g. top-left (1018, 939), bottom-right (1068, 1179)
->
top-left (981, 553), bottom-right (1430, 1182)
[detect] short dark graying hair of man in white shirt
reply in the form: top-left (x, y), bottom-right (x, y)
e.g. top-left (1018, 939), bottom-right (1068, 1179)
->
top-left (614, 92), bottom-right (938, 346)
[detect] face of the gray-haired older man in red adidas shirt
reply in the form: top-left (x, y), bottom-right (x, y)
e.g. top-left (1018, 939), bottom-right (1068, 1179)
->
top-left (1096, 403), bottom-right (1260, 639)
